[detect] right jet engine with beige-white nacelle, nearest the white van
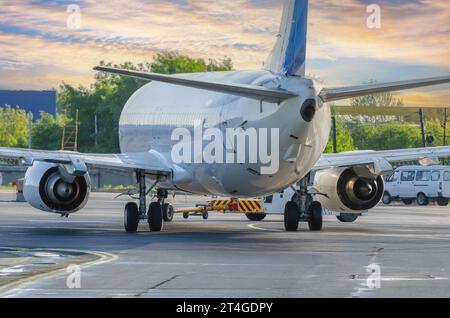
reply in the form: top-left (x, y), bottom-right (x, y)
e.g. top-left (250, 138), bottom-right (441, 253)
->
top-left (314, 168), bottom-right (384, 212)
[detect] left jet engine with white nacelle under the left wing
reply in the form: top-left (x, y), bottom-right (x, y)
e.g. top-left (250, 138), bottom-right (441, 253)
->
top-left (23, 162), bottom-right (91, 214)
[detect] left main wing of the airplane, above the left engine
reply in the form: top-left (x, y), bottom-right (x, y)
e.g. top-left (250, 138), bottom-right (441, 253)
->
top-left (0, 147), bottom-right (172, 176)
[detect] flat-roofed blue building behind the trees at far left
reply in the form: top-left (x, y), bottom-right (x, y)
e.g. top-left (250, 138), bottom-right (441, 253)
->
top-left (0, 90), bottom-right (56, 120)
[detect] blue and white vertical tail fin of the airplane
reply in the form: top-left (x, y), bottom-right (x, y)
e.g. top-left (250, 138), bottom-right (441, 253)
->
top-left (266, 0), bottom-right (308, 76)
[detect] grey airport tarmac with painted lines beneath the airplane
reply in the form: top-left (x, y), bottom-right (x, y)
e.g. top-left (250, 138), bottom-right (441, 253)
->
top-left (0, 191), bottom-right (450, 298)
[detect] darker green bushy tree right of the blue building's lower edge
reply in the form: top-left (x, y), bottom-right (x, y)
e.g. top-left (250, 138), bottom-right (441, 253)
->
top-left (31, 112), bottom-right (64, 150)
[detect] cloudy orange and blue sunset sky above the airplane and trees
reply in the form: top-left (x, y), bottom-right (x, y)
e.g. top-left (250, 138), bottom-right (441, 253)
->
top-left (0, 0), bottom-right (450, 107)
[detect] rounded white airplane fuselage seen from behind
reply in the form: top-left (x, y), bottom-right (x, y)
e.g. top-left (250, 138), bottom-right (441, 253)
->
top-left (119, 71), bottom-right (331, 197)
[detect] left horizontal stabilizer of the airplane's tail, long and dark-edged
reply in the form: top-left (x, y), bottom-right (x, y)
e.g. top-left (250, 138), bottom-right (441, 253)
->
top-left (94, 66), bottom-right (298, 103)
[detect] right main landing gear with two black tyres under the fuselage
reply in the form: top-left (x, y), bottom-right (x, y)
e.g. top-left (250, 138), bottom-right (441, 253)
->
top-left (284, 175), bottom-right (323, 232)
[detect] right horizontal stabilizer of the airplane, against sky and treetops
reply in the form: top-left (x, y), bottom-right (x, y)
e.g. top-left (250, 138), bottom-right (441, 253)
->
top-left (319, 76), bottom-right (450, 103)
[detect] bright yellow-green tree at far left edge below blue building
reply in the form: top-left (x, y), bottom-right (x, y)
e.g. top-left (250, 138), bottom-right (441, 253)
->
top-left (0, 105), bottom-right (28, 148)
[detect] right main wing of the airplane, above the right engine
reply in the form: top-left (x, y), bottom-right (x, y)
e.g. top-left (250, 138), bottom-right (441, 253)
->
top-left (314, 147), bottom-right (450, 175)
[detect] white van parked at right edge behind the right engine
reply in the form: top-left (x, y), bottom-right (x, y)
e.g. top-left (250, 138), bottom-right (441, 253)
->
top-left (383, 166), bottom-right (450, 206)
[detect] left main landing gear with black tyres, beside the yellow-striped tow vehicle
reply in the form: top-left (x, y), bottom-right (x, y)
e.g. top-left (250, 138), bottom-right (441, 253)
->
top-left (124, 171), bottom-right (173, 233)
